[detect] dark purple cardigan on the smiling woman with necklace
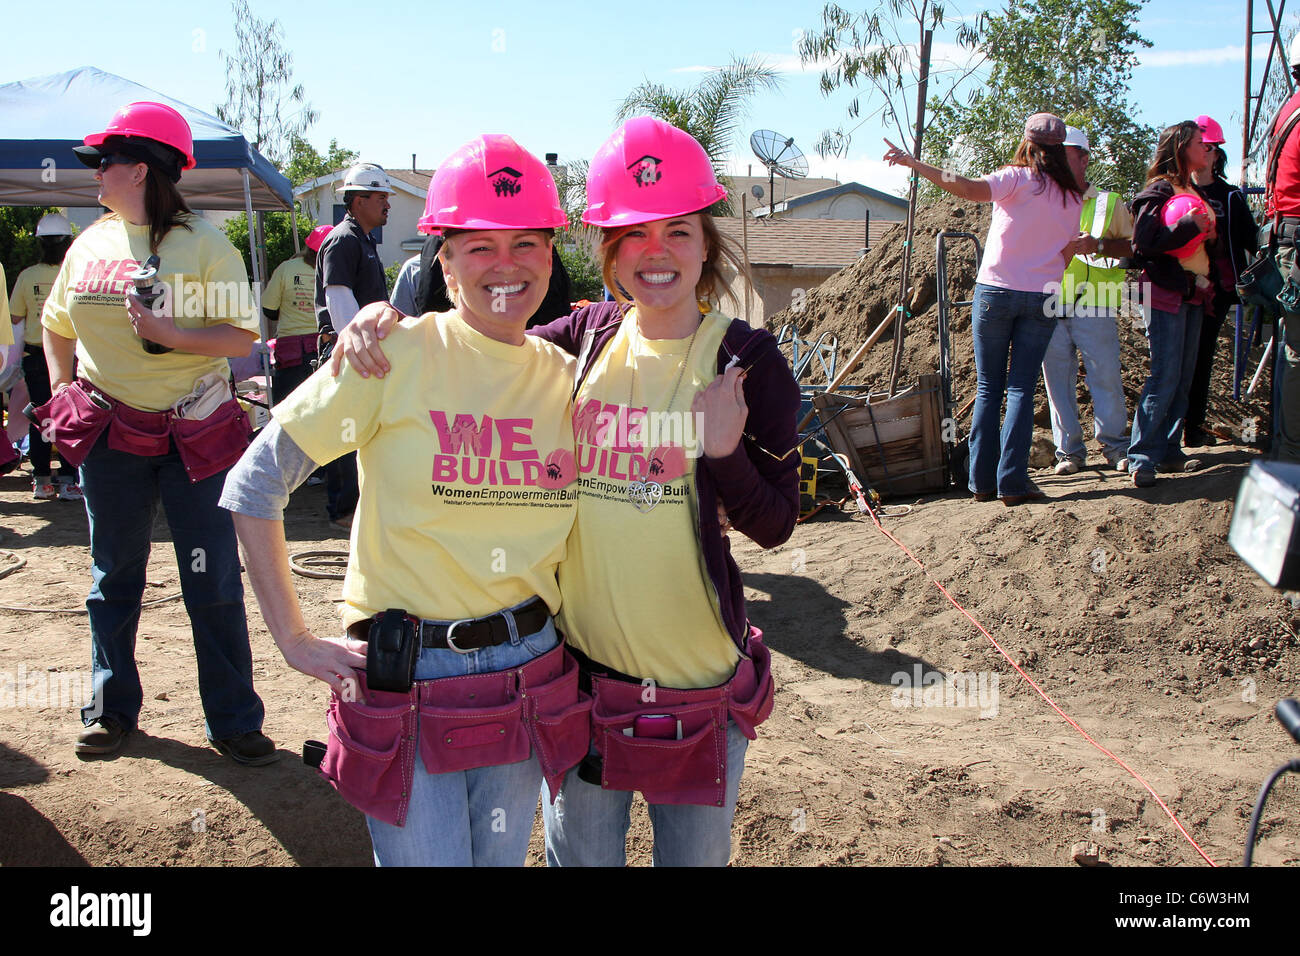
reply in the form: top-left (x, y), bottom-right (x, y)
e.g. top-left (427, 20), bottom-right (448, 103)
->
top-left (528, 302), bottom-right (800, 650)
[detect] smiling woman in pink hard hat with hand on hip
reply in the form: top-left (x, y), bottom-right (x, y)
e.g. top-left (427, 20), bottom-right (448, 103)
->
top-left (222, 135), bottom-right (590, 866)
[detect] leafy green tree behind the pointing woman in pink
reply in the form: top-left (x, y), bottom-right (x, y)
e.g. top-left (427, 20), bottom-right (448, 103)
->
top-left (924, 0), bottom-right (1159, 195)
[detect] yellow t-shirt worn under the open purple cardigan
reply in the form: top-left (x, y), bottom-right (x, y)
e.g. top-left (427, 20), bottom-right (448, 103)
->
top-left (560, 310), bottom-right (740, 688)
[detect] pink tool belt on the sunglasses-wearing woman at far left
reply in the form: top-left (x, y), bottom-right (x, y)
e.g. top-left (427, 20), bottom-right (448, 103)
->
top-left (35, 378), bottom-right (252, 483)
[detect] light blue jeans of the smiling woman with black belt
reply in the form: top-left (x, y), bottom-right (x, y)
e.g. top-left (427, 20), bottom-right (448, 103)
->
top-left (365, 613), bottom-right (559, 866)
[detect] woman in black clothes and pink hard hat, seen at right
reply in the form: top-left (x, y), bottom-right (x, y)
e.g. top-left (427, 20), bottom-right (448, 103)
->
top-left (1183, 116), bottom-right (1260, 447)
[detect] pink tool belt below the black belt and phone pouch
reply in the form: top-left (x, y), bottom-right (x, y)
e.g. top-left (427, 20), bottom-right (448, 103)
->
top-left (320, 641), bottom-right (592, 826)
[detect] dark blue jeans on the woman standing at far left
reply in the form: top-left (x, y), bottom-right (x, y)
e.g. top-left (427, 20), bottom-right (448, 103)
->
top-left (81, 432), bottom-right (263, 740)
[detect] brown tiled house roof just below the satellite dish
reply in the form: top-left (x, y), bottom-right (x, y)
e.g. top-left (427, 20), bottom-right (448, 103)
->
top-left (714, 216), bottom-right (894, 269)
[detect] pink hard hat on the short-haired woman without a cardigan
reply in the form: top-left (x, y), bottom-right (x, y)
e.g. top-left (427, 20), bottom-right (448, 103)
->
top-left (419, 134), bottom-right (568, 233)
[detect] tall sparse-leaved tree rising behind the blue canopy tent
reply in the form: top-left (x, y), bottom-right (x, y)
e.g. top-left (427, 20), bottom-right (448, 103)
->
top-left (217, 0), bottom-right (320, 164)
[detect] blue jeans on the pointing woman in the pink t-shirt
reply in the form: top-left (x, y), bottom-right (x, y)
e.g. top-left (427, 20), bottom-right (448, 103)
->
top-left (970, 282), bottom-right (1057, 498)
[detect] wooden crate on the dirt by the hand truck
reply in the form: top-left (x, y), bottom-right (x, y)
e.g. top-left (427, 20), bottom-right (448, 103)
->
top-left (813, 375), bottom-right (946, 497)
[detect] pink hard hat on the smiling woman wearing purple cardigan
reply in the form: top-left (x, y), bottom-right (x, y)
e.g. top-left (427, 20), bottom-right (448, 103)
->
top-left (582, 116), bottom-right (727, 226)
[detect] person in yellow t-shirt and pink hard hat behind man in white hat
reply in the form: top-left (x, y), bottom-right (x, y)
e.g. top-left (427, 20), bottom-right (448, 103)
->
top-left (261, 225), bottom-right (333, 402)
